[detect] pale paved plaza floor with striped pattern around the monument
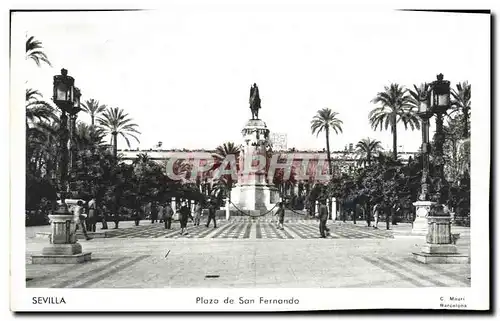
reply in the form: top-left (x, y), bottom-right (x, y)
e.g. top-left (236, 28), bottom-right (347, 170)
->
top-left (26, 220), bottom-right (470, 288)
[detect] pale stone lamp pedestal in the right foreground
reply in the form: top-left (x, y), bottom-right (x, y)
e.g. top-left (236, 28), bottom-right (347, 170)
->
top-left (413, 216), bottom-right (469, 264)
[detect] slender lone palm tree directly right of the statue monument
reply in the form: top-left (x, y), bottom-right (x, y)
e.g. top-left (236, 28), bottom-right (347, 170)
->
top-left (311, 108), bottom-right (342, 176)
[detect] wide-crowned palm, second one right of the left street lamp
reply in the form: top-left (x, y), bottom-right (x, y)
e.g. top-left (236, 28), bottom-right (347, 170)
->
top-left (97, 107), bottom-right (140, 160)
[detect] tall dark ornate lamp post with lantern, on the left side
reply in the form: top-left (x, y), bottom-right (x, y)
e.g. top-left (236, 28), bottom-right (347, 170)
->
top-left (52, 68), bottom-right (75, 193)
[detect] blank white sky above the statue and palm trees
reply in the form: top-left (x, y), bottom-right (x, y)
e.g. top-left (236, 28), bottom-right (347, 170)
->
top-left (12, 6), bottom-right (489, 152)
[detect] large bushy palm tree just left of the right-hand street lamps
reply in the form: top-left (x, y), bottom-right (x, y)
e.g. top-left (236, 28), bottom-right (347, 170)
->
top-left (368, 84), bottom-right (420, 159)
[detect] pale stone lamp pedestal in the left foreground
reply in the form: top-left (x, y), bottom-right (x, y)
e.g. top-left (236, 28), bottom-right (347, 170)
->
top-left (32, 214), bottom-right (91, 264)
